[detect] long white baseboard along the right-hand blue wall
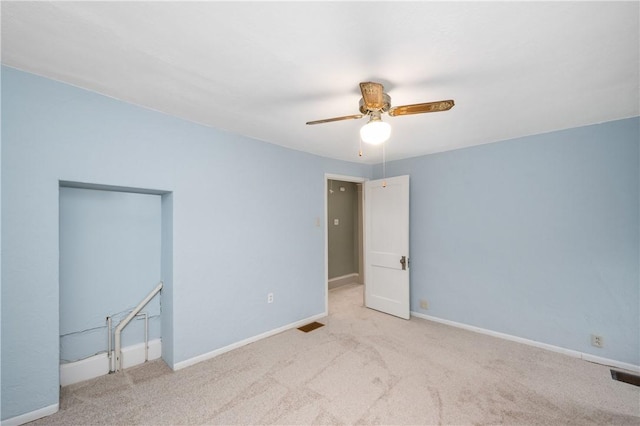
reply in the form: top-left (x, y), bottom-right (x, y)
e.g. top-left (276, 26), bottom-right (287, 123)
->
top-left (411, 312), bottom-right (640, 372)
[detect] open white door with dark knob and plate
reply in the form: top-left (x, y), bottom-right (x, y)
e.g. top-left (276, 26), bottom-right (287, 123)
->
top-left (364, 176), bottom-right (410, 319)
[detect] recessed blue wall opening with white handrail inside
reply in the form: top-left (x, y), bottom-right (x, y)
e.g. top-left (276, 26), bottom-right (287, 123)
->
top-left (59, 181), bottom-right (173, 386)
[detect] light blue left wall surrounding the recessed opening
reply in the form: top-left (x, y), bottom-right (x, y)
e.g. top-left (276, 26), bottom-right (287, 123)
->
top-left (1, 67), bottom-right (372, 419)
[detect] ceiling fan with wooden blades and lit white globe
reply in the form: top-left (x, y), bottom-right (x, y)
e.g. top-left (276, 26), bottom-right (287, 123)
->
top-left (307, 81), bottom-right (454, 145)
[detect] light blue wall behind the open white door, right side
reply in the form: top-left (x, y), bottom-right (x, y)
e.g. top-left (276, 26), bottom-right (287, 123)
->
top-left (374, 117), bottom-right (640, 365)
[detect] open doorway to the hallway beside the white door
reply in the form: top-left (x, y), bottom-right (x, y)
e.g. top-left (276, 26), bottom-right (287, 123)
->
top-left (325, 175), bottom-right (365, 308)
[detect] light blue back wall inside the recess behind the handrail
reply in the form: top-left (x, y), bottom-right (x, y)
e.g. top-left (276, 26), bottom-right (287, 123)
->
top-left (59, 187), bottom-right (162, 363)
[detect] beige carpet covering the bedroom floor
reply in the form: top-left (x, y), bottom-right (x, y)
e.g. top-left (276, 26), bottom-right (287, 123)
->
top-left (34, 285), bottom-right (640, 425)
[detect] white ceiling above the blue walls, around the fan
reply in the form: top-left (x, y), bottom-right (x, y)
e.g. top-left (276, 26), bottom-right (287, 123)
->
top-left (1, 1), bottom-right (640, 164)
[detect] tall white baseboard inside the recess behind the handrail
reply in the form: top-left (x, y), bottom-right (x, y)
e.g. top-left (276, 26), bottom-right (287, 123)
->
top-left (60, 339), bottom-right (162, 386)
